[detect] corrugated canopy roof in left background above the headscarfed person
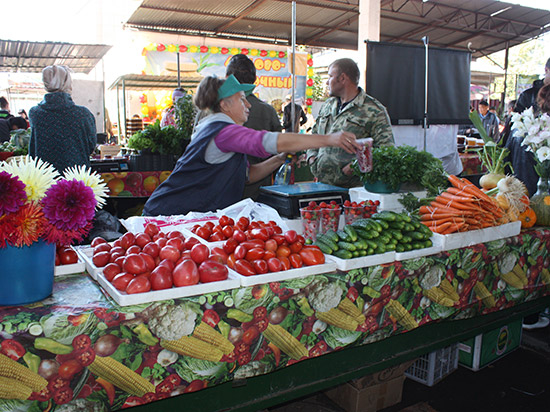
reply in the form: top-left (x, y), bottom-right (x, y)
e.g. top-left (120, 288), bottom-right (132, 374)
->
top-left (0, 40), bottom-right (111, 74)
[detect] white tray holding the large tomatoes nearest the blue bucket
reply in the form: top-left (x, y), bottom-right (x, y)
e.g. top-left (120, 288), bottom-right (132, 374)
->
top-left (97, 270), bottom-right (241, 306)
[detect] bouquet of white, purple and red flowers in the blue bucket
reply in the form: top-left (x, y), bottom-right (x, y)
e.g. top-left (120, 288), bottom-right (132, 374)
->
top-left (0, 156), bottom-right (107, 248)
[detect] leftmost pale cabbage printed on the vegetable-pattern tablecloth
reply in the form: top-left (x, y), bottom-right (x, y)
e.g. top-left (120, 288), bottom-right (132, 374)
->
top-left (40, 313), bottom-right (98, 345)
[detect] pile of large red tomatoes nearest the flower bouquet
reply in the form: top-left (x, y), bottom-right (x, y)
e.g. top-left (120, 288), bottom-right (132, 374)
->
top-left (91, 223), bottom-right (229, 294)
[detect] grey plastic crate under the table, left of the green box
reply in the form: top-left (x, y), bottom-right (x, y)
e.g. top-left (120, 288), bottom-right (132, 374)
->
top-left (405, 343), bottom-right (458, 386)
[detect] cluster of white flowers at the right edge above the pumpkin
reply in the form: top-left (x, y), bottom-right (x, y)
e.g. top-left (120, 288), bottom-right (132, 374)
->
top-left (512, 107), bottom-right (550, 177)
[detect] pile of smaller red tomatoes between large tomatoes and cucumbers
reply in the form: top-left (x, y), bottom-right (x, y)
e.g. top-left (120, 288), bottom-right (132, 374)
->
top-left (213, 216), bottom-right (325, 276)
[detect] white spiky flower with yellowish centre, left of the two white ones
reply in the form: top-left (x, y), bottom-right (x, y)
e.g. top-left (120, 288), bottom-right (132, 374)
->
top-left (0, 156), bottom-right (59, 202)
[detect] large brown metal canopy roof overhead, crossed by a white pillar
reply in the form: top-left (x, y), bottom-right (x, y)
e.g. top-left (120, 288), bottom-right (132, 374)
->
top-left (126, 0), bottom-right (550, 57)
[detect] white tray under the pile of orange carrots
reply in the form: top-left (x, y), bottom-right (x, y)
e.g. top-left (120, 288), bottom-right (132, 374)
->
top-left (432, 221), bottom-right (521, 250)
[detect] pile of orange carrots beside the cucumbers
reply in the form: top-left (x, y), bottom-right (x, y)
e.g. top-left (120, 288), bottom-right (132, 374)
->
top-left (419, 175), bottom-right (504, 235)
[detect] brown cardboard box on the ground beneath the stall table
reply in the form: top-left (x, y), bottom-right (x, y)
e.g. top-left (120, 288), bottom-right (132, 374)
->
top-left (325, 361), bottom-right (413, 412)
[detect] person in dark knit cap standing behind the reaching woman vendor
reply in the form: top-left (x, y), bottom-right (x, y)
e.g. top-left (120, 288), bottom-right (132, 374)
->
top-left (225, 54), bottom-right (282, 200)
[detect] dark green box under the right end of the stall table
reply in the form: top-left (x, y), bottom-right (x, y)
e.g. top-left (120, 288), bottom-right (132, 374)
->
top-left (458, 319), bottom-right (522, 371)
